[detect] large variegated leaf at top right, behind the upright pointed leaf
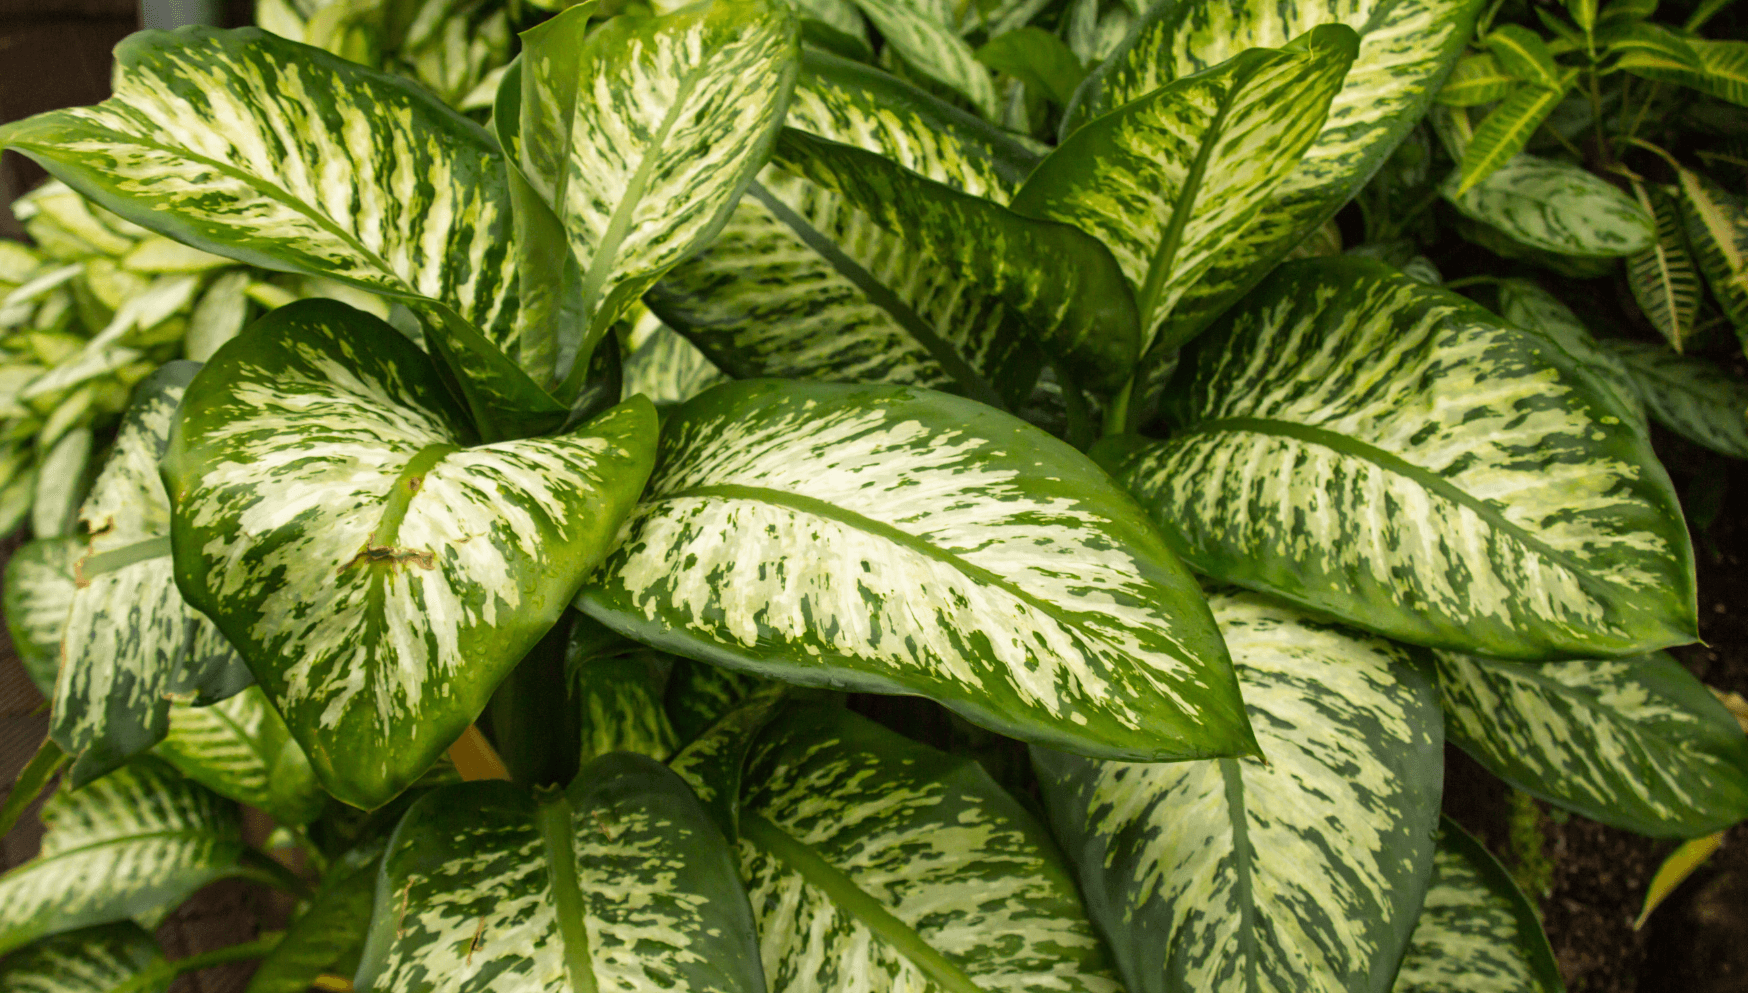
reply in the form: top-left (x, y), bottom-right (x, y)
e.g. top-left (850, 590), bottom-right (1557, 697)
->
top-left (1063, 0), bottom-right (1481, 349)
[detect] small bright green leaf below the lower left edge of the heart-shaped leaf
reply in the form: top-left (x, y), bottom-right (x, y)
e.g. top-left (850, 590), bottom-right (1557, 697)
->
top-left (154, 687), bottom-right (327, 825)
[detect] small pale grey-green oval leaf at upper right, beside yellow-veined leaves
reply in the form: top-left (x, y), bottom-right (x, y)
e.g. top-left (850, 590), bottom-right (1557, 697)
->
top-left (1444, 153), bottom-right (1657, 257)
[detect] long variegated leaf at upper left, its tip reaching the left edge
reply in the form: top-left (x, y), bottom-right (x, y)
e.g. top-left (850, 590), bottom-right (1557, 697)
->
top-left (0, 28), bottom-right (516, 357)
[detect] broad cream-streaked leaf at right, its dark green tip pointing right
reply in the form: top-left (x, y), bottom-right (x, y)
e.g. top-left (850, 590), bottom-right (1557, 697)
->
top-left (1101, 257), bottom-right (1697, 659)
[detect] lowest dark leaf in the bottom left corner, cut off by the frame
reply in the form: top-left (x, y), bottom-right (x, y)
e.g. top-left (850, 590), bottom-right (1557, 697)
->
top-left (0, 921), bottom-right (168, 993)
